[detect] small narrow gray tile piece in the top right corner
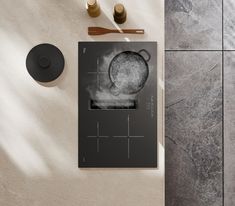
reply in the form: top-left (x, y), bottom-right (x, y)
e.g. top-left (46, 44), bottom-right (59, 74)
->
top-left (224, 0), bottom-right (235, 50)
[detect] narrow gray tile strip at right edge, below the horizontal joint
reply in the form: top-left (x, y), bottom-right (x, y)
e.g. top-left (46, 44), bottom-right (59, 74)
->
top-left (224, 52), bottom-right (235, 206)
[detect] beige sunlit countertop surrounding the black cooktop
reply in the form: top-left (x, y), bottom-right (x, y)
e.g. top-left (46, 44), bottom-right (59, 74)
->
top-left (0, 0), bottom-right (164, 206)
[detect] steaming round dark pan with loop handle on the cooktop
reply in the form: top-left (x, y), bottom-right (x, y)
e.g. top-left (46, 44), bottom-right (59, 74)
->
top-left (109, 49), bottom-right (151, 95)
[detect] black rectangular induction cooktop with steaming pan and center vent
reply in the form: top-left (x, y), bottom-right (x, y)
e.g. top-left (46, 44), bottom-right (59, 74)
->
top-left (79, 42), bottom-right (157, 167)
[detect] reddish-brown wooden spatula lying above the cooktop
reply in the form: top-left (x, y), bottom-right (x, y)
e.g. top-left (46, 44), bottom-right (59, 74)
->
top-left (88, 27), bottom-right (144, 35)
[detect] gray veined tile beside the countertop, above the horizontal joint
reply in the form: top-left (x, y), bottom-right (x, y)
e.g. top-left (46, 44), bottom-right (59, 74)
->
top-left (165, 0), bottom-right (222, 50)
